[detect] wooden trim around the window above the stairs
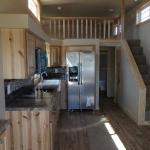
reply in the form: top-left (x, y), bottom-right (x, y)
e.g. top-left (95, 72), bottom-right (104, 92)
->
top-left (136, 1), bottom-right (150, 25)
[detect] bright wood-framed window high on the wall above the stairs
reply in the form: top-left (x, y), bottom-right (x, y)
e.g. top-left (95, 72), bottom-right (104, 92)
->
top-left (136, 2), bottom-right (150, 24)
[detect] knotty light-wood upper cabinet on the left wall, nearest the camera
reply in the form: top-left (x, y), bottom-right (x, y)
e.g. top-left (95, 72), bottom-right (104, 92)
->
top-left (0, 28), bottom-right (45, 79)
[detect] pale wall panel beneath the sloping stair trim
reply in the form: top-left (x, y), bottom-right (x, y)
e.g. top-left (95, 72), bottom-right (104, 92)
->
top-left (118, 49), bottom-right (139, 122)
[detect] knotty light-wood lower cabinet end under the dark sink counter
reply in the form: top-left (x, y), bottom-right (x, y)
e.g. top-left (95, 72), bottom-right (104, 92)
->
top-left (5, 111), bottom-right (54, 150)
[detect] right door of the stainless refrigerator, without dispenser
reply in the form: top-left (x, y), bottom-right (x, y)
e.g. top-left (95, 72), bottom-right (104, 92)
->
top-left (80, 51), bottom-right (95, 109)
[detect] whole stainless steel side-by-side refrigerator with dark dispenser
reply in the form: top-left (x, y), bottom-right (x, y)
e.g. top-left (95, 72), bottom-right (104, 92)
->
top-left (67, 51), bottom-right (95, 110)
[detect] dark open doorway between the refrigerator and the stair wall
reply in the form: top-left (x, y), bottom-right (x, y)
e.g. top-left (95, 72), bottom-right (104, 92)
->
top-left (99, 47), bottom-right (116, 106)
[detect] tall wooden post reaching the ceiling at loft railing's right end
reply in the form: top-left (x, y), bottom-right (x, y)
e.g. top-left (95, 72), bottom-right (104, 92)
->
top-left (121, 0), bottom-right (125, 39)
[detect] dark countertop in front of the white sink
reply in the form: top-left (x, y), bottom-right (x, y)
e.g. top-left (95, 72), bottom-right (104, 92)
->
top-left (6, 90), bottom-right (57, 112)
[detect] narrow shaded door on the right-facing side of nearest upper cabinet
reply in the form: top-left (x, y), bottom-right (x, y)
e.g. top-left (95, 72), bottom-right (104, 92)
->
top-left (26, 33), bottom-right (36, 76)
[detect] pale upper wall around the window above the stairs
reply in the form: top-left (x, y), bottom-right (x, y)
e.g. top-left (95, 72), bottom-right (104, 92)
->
top-left (126, 0), bottom-right (150, 65)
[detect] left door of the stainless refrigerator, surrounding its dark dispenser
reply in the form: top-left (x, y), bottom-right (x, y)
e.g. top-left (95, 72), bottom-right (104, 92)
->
top-left (67, 52), bottom-right (80, 109)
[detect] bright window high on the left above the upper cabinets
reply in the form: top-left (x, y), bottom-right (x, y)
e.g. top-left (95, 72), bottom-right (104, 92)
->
top-left (28, 0), bottom-right (40, 21)
